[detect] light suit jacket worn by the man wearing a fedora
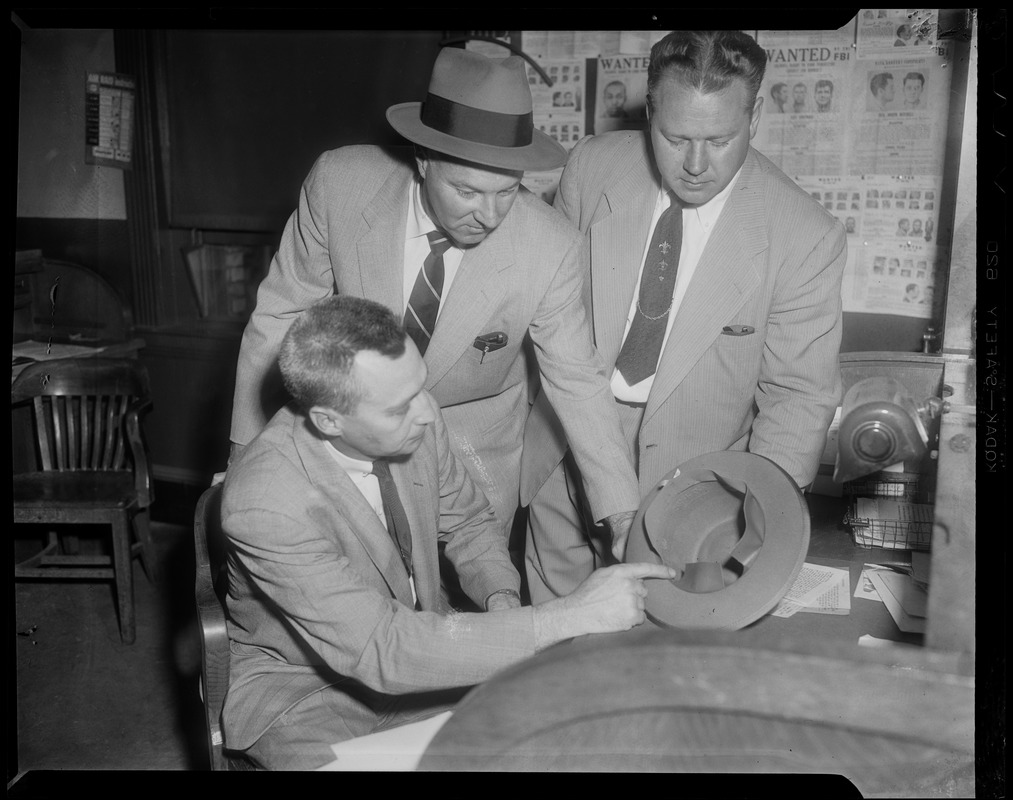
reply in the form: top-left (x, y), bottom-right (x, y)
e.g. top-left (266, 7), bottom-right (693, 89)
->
top-left (232, 146), bottom-right (638, 525)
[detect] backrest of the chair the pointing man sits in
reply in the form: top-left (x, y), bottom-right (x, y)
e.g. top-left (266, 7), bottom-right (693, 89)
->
top-left (193, 483), bottom-right (229, 770)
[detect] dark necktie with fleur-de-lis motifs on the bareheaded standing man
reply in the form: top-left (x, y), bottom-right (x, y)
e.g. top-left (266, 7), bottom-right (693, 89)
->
top-left (616, 199), bottom-right (683, 386)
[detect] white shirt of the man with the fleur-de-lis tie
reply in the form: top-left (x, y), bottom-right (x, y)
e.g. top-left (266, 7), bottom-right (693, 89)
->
top-left (612, 168), bottom-right (742, 403)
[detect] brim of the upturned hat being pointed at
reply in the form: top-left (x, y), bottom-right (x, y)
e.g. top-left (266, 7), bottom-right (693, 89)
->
top-left (625, 451), bottom-right (809, 630)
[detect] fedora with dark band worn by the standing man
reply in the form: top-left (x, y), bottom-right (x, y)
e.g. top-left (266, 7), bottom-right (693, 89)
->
top-left (387, 48), bottom-right (566, 170)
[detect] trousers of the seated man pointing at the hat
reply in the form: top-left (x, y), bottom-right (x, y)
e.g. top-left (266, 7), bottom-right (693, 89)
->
top-left (243, 687), bottom-right (471, 770)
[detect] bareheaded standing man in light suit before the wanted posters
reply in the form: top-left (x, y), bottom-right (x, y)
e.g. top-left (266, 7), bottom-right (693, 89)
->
top-left (522, 31), bottom-right (846, 603)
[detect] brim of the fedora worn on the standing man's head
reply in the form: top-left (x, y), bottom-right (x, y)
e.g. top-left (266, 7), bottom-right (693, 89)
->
top-left (387, 102), bottom-right (566, 171)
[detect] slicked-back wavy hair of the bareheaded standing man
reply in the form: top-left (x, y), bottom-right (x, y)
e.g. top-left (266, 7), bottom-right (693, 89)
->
top-left (647, 30), bottom-right (767, 111)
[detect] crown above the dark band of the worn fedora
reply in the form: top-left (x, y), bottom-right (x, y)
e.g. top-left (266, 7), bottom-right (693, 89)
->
top-left (430, 48), bottom-right (532, 114)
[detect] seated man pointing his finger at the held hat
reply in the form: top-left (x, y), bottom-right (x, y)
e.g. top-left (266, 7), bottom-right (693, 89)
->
top-left (222, 296), bottom-right (677, 769)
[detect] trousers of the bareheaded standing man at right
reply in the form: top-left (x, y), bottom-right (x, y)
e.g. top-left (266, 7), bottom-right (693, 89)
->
top-left (524, 400), bottom-right (644, 606)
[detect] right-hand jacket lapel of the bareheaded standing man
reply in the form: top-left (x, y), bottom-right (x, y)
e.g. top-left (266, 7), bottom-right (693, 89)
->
top-left (644, 151), bottom-right (768, 422)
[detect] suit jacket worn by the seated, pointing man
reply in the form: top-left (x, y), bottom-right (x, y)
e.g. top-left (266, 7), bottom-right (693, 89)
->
top-left (222, 408), bottom-right (535, 749)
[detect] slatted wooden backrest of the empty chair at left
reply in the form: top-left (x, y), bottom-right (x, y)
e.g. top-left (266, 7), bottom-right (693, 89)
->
top-left (11, 356), bottom-right (152, 508)
